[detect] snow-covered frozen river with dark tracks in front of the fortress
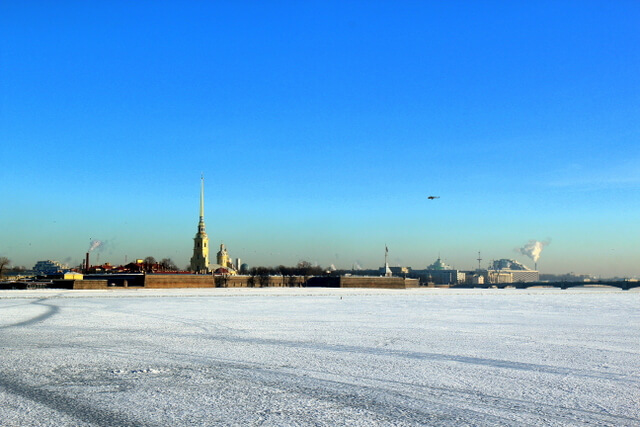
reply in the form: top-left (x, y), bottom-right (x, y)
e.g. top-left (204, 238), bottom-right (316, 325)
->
top-left (0, 289), bottom-right (640, 426)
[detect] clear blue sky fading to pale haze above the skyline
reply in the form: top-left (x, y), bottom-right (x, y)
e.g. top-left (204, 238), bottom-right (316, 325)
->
top-left (0, 1), bottom-right (640, 276)
